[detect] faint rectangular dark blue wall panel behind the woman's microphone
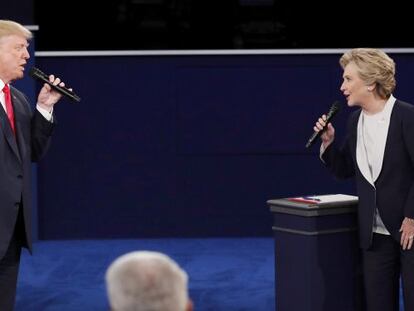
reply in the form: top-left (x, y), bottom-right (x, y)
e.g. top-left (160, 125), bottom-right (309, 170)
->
top-left (178, 65), bottom-right (330, 153)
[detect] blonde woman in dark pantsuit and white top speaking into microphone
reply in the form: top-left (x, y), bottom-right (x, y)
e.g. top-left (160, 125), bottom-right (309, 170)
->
top-left (314, 49), bottom-right (414, 311)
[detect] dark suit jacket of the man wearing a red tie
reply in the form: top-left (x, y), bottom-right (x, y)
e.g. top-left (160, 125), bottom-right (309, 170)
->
top-left (0, 87), bottom-right (53, 259)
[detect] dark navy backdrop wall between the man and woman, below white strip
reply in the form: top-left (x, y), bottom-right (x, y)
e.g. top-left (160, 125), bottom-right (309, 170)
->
top-left (32, 55), bottom-right (414, 239)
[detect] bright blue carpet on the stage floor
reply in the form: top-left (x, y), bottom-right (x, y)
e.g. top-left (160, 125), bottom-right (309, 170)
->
top-left (16, 238), bottom-right (275, 311)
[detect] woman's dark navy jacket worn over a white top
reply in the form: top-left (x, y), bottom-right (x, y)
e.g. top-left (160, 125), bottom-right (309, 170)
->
top-left (322, 100), bottom-right (414, 249)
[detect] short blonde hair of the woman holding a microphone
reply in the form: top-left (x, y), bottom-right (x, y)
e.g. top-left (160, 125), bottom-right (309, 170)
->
top-left (339, 48), bottom-right (396, 99)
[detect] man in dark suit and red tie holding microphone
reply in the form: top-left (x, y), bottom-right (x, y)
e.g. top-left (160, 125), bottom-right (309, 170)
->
top-left (0, 20), bottom-right (64, 311)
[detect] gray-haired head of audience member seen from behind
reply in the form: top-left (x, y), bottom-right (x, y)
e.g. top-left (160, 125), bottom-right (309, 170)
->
top-left (106, 251), bottom-right (189, 311)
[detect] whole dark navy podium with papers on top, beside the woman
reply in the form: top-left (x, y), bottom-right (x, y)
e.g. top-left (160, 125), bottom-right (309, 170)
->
top-left (267, 195), bottom-right (363, 311)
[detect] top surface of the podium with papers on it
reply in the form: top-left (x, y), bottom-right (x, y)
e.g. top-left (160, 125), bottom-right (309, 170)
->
top-left (267, 194), bottom-right (358, 217)
